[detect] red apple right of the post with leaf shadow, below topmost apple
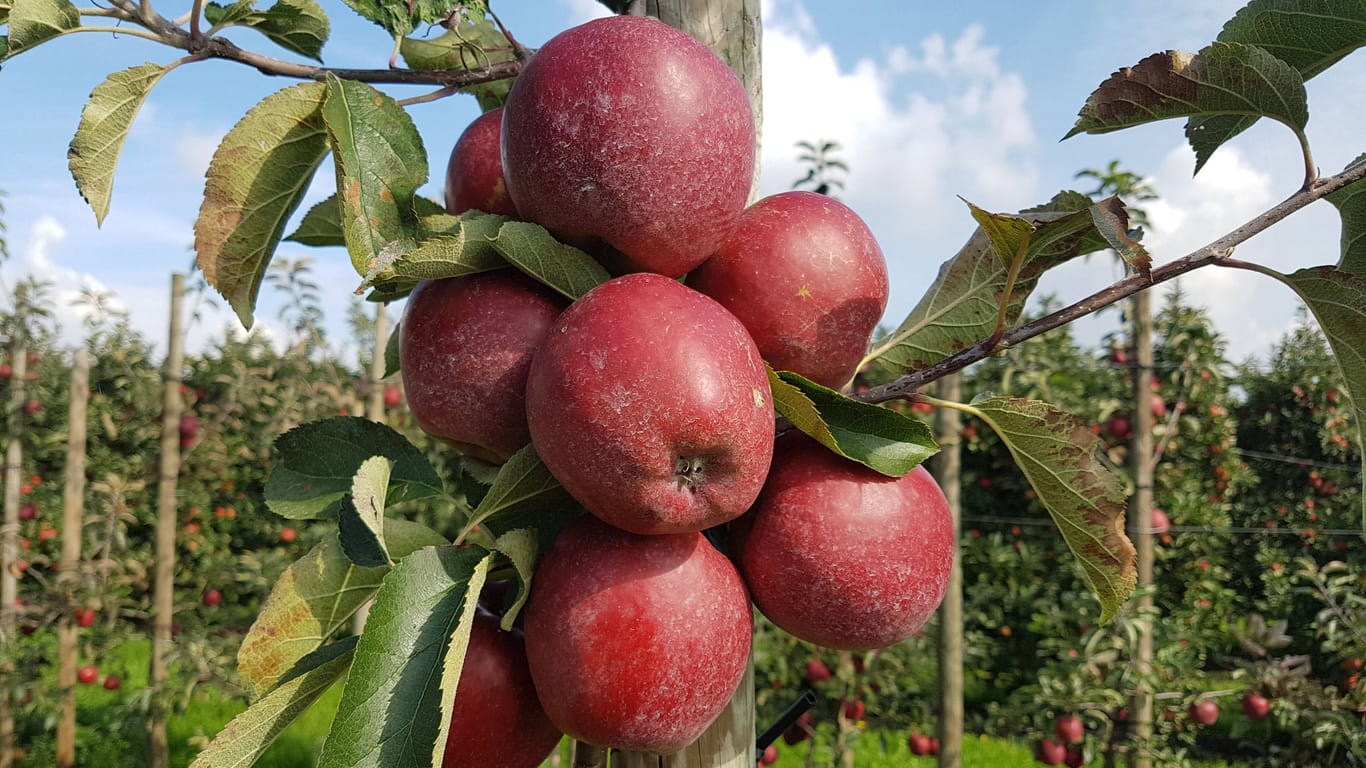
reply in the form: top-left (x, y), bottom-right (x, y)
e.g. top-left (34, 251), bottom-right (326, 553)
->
top-left (687, 191), bottom-right (888, 389)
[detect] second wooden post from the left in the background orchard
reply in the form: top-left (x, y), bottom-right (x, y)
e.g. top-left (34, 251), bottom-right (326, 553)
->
top-left (57, 348), bottom-right (90, 768)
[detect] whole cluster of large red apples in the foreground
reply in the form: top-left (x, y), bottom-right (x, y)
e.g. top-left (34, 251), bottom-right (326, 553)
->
top-left (400, 16), bottom-right (953, 768)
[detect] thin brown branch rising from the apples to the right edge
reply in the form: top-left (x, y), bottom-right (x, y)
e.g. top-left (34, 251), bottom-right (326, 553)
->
top-left (852, 164), bottom-right (1366, 403)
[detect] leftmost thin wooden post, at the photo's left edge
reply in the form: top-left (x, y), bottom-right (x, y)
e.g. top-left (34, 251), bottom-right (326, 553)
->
top-left (0, 333), bottom-right (29, 768)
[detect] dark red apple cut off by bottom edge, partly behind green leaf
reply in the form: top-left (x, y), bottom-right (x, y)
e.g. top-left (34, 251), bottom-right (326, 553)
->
top-left (441, 611), bottom-right (560, 768)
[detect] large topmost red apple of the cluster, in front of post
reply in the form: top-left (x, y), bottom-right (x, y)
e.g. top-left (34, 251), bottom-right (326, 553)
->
top-left (503, 16), bottom-right (755, 276)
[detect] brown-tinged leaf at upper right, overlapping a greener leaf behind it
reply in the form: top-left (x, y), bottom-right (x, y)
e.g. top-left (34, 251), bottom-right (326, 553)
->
top-left (1063, 42), bottom-right (1309, 138)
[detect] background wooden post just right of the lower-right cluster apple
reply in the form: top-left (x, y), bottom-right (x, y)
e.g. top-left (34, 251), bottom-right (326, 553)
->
top-left (934, 373), bottom-right (963, 768)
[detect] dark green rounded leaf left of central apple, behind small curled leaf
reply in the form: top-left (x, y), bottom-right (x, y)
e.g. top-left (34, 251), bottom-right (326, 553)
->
top-left (265, 415), bottom-right (445, 519)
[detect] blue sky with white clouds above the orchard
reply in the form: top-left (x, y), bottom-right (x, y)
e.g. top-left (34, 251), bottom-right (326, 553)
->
top-left (0, 0), bottom-right (1366, 358)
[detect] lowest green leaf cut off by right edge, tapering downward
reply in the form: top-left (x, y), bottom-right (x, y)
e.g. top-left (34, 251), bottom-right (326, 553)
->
top-left (1280, 266), bottom-right (1366, 533)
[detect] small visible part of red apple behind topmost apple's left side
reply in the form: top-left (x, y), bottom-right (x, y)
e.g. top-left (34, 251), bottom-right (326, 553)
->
top-left (445, 107), bottom-right (516, 217)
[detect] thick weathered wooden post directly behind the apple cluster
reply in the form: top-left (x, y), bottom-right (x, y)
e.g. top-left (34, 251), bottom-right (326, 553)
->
top-left (612, 0), bottom-right (764, 768)
